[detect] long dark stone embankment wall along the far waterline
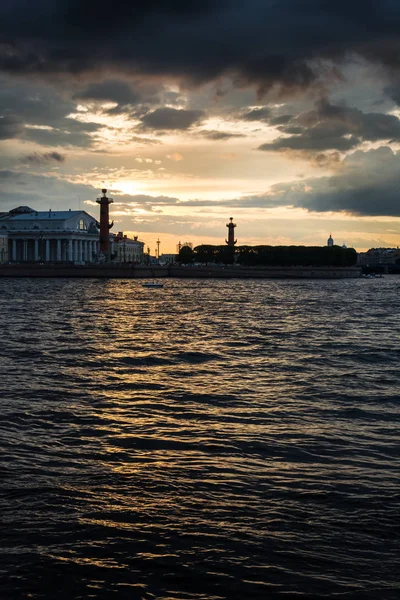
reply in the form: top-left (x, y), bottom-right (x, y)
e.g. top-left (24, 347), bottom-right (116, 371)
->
top-left (0, 264), bottom-right (361, 279)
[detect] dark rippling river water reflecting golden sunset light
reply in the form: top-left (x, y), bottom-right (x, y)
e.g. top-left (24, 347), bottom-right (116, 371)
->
top-left (0, 276), bottom-right (400, 600)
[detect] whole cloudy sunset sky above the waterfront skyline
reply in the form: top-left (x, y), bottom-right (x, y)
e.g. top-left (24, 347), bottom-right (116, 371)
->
top-left (0, 0), bottom-right (400, 253)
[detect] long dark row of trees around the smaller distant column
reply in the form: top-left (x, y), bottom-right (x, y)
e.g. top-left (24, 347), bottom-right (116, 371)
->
top-left (177, 244), bottom-right (357, 267)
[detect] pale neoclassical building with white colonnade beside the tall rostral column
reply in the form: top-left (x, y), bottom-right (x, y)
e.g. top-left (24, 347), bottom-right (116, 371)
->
top-left (0, 206), bottom-right (99, 263)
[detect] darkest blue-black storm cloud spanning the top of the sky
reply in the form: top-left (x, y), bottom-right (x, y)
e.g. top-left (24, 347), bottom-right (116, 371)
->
top-left (0, 0), bottom-right (400, 91)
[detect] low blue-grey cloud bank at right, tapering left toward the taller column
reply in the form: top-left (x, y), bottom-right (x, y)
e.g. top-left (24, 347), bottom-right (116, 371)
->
top-left (104, 146), bottom-right (400, 217)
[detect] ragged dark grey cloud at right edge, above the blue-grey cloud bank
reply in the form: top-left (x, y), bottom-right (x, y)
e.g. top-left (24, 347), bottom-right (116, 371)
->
top-left (259, 100), bottom-right (400, 152)
